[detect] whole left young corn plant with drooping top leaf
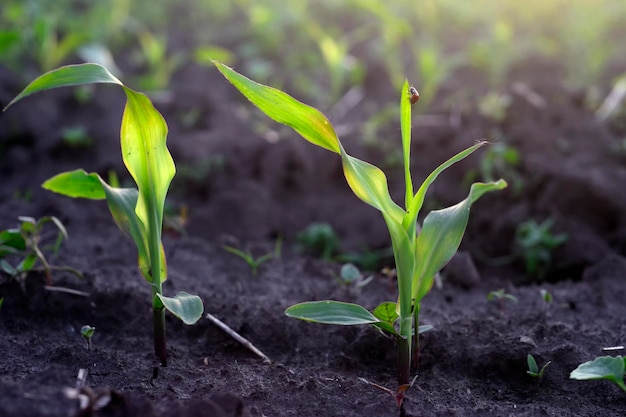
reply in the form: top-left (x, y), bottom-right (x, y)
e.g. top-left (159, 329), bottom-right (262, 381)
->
top-left (5, 64), bottom-right (203, 366)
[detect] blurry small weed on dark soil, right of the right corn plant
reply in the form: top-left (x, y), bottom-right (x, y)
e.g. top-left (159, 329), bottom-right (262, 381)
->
top-left (515, 219), bottom-right (568, 281)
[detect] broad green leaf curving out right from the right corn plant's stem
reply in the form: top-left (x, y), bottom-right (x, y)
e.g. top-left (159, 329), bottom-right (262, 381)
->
top-left (412, 180), bottom-right (506, 303)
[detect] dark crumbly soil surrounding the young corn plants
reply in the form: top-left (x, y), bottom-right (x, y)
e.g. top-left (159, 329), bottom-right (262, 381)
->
top-left (0, 56), bottom-right (626, 417)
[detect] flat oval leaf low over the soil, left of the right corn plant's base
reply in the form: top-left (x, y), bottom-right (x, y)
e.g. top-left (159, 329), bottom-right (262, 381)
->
top-left (285, 300), bottom-right (380, 326)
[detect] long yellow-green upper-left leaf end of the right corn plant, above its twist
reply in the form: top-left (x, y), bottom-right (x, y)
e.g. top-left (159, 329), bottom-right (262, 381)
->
top-left (213, 61), bottom-right (340, 153)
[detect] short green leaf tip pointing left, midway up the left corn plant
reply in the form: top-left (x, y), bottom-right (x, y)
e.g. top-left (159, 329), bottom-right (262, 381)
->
top-left (42, 169), bottom-right (106, 200)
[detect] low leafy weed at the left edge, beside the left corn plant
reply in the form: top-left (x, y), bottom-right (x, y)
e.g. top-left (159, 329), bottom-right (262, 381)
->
top-left (0, 216), bottom-right (83, 289)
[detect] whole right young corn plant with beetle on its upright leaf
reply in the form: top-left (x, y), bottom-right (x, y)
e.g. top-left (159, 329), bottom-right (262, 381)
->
top-left (215, 62), bottom-right (506, 406)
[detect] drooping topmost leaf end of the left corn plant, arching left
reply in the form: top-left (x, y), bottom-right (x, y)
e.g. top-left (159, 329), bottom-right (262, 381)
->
top-left (4, 64), bottom-right (122, 110)
